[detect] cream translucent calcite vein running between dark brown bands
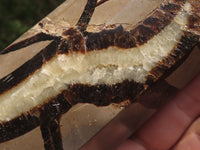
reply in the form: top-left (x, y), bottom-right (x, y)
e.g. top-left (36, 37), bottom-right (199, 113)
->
top-left (0, 3), bottom-right (190, 122)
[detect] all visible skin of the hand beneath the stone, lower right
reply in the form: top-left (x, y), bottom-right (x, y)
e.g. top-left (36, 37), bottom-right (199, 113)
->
top-left (81, 62), bottom-right (200, 150)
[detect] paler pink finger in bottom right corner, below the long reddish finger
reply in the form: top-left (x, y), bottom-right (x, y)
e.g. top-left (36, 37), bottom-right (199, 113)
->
top-left (172, 117), bottom-right (200, 150)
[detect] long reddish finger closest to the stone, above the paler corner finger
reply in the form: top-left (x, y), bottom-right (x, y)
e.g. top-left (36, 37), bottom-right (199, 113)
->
top-left (130, 74), bottom-right (200, 150)
